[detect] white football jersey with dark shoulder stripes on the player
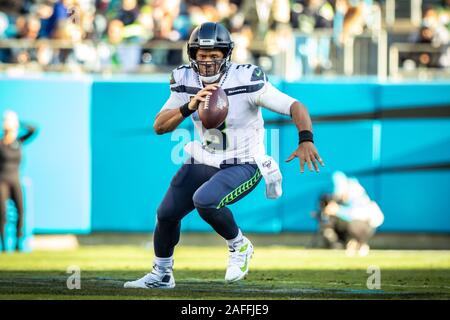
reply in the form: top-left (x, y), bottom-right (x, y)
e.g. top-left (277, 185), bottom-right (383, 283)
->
top-left (161, 63), bottom-right (295, 162)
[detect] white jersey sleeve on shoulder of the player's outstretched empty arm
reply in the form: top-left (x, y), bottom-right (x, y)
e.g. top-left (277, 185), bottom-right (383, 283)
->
top-left (244, 66), bottom-right (296, 116)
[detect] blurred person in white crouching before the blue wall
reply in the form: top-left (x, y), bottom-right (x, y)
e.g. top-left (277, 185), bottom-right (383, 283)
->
top-left (321, 171), bottom-right (384, 256)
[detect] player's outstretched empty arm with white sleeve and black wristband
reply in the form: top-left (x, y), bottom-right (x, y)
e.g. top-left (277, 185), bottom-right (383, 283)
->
top-left (255, 82), bottom-right (324, 173)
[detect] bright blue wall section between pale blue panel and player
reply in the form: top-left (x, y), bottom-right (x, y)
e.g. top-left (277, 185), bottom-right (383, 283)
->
top-left (92, 80), bottom-right (177, 231)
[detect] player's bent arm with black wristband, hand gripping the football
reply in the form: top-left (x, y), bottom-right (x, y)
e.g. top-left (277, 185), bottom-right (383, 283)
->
top-left (153, 84), bottom-right (218, 134)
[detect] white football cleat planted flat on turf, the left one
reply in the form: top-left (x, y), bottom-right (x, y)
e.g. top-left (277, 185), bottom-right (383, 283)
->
top-left (123, 265), bottom-right (175, 289)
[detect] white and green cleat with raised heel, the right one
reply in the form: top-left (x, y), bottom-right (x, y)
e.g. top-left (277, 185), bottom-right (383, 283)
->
top-left (225, 237), bottom-right (253, 282)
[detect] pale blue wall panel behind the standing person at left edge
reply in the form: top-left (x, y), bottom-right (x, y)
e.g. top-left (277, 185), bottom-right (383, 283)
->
top-left (0, 76), bottom-right (92, 233)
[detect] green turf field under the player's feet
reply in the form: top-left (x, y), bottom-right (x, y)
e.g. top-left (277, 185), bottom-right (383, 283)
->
top-left (0, 245), bottom-right (450, 299)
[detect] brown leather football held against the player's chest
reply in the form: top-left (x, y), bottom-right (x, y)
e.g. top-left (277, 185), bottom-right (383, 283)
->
top-left (198, 87), bottom-right (229, 129)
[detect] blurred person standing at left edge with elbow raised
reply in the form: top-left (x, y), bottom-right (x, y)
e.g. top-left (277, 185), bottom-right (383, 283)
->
top-left (0, 110), bottom-right (36, 252)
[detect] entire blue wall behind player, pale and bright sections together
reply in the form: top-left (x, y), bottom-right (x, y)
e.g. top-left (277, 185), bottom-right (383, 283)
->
top-left (0, 76), bottom-right (450, 233)
